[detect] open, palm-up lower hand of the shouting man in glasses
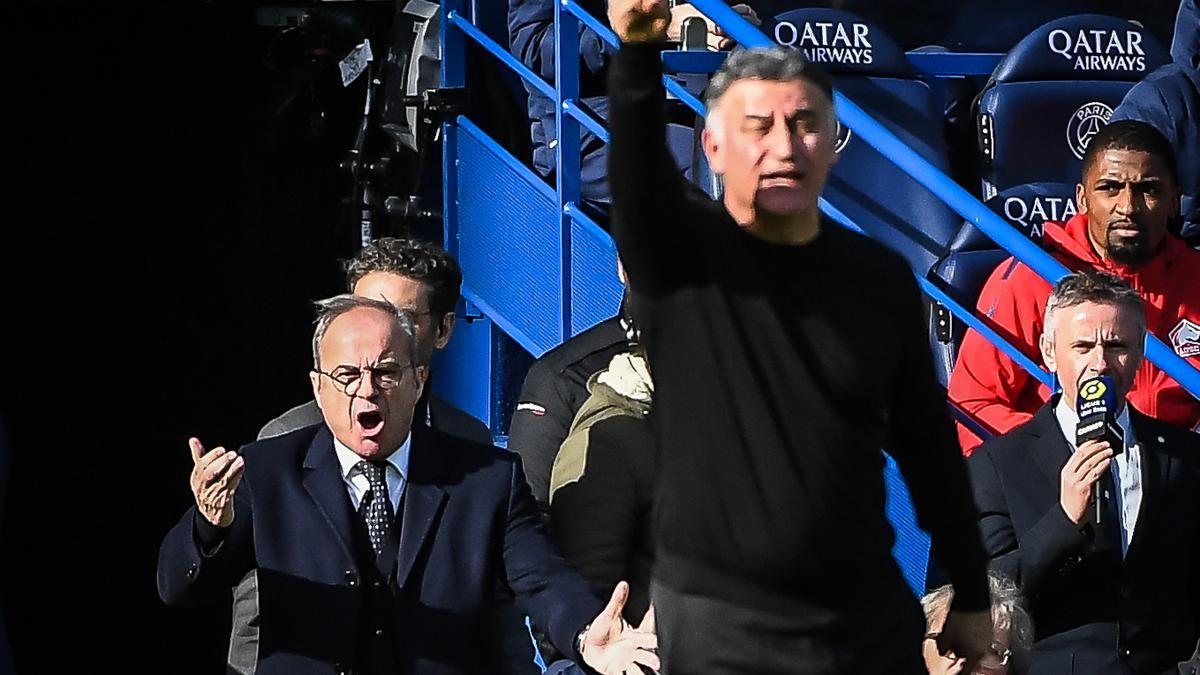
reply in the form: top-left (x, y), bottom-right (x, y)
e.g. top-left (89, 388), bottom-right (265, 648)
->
top-left (580, 581), bottom-right (660, 675)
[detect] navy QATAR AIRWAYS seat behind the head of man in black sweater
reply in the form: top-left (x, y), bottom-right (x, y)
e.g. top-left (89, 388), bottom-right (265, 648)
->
top-left (774, 8), bottom-right (960, 275)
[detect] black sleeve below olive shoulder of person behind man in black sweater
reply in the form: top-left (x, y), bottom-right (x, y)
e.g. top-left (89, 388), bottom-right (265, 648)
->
top-left (550, 417), bottom-right (644, 596)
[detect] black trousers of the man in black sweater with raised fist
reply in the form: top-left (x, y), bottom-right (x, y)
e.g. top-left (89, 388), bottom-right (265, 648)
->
top-left (650, 581), bottom-right (925, 675)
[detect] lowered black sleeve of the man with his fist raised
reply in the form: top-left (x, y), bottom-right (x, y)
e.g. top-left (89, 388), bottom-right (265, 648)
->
top-left (888, 263), bottom-right (989, 610)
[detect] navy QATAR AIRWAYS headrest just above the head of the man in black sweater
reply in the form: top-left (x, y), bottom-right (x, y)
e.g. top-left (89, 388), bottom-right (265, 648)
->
top-left (774, 8), bottom-right (917, 79)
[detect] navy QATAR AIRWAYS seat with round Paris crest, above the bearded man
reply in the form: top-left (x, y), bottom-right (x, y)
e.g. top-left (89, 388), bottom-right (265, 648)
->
top-left (976, 14), bottom-right (1170, 199)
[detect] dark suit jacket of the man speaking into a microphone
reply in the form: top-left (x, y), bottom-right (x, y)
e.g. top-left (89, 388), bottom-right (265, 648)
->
top-left (967, 396), bottom-right (1200, 675)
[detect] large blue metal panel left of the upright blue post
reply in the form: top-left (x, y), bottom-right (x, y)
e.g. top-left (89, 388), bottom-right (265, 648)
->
top-left (448, 119), bottom-right (563, 353)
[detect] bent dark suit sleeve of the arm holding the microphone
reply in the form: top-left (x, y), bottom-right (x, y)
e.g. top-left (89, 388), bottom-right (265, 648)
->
top-left (967, 446), bottom-right (1090, 593)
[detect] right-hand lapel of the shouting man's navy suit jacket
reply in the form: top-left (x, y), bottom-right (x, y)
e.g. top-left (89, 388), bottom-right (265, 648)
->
top-left (396, 422), bottom-right (448, 587)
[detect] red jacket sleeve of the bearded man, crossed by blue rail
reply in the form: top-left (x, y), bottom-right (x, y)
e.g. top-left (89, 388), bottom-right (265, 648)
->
top-left (947, 258), bottom-right (1050, 456)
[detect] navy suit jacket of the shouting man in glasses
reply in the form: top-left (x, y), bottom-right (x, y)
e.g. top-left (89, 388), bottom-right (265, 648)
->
top-left (158, 424), bottom-right (602, 675)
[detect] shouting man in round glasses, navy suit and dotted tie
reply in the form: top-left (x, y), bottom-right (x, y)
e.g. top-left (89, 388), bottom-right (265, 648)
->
top-left (158, 295), bottom-right (659, 675)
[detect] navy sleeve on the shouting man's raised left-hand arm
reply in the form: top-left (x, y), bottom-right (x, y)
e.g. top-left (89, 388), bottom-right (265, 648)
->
top-left (158, 466), bottom-right (254, 607)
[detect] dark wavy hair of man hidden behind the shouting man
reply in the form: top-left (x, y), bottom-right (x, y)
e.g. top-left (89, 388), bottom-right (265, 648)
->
top-left (346, 237), bottom-right (462, 315)
